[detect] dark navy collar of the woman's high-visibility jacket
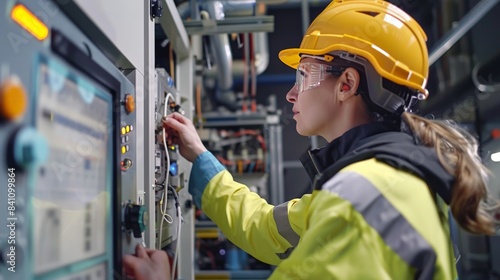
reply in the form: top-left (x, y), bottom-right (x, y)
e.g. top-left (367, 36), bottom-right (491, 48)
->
top-left (301, 120), bottom-right (455, 204)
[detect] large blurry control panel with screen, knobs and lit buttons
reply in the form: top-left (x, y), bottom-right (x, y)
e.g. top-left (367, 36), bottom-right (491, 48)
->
top-left (0, 0), bottom-right (142, 280)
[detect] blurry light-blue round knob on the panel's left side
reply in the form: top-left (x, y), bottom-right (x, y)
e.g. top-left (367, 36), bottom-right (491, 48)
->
top-left (9, 127), bottom-right (49, 169)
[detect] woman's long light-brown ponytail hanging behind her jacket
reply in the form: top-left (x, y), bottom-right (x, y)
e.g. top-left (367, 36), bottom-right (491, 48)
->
top-left (402, 112), bottom-right (495, 234)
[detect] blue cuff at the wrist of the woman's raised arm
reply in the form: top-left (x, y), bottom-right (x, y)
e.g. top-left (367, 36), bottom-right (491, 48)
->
top-left (189, 151), bottom-right (225, 209)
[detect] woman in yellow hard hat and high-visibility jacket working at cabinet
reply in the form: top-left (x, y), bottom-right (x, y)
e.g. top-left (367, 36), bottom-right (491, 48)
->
top-left (126, 0), bottom-right (494, 279)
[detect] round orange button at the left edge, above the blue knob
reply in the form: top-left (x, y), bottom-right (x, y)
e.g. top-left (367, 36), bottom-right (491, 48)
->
top-left (0, 76), bottom-right (28, 120)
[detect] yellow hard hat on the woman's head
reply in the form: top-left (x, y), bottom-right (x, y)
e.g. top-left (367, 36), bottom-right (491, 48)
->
top-left (279, 0), bottom-right (429, 99)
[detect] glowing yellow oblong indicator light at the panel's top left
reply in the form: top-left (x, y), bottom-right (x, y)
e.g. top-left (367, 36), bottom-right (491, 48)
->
top-left (10, 4), bottom-right (49, 40)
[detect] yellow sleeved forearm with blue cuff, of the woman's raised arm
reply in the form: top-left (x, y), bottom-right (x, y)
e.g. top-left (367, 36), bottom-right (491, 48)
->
top-left (190, 153), bottom-right (291, 264)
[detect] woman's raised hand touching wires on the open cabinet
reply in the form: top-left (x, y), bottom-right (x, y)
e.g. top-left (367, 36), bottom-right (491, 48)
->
top-left (163, 113), bottom-right (207, 162)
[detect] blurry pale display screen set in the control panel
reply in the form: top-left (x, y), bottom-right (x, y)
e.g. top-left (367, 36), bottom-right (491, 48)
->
top-left (32, 59), bottom-right (113, 279)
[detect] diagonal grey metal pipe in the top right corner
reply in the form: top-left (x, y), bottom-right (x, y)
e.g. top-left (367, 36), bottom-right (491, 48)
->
top-left (429, 0), bottom-right (499, 66)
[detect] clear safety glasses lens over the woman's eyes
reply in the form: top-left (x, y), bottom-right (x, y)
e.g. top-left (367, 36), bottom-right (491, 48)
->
top-left (295, 62), bottom-right (333, 94)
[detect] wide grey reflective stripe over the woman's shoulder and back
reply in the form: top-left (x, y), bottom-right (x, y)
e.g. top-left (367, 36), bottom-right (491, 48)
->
top-left (322, 172), bottom-right (436, 279)
